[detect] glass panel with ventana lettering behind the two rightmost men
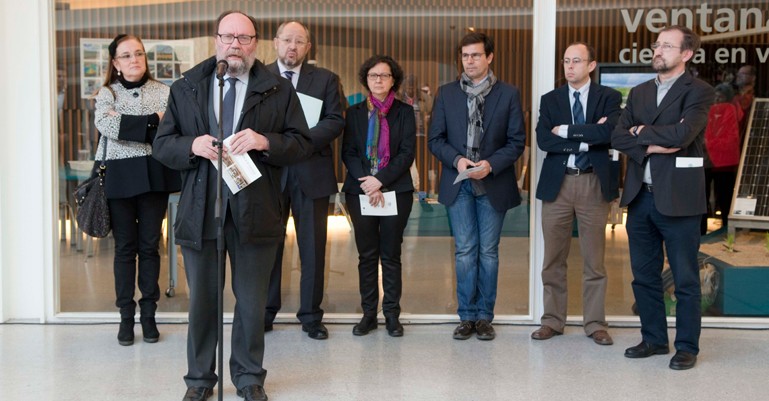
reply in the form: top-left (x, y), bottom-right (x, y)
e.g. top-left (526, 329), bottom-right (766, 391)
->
top-left (554, 0), bottom-right (769, 317)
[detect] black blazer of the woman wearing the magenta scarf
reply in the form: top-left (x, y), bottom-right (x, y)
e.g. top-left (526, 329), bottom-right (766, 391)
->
top-left (342, 100), bottom-right (417, 195)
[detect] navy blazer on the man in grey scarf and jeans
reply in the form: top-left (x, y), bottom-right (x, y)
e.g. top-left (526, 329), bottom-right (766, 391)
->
top-left (428, 81), bottom-right (526, 212)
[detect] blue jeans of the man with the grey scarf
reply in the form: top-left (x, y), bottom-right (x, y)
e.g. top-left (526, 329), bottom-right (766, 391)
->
top-left (446, 180), bottom-right (505, 321)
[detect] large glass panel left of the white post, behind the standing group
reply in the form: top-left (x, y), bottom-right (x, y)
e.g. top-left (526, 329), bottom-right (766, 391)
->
top-left (56, 0), bottom-right (532, 316)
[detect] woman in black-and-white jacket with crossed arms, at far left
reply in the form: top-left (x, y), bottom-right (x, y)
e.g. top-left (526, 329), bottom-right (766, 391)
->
top-left (95, 34), bottom-right (181, 345)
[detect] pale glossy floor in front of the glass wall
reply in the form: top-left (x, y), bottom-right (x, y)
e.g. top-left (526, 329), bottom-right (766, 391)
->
top-left (0, 324), bottom-right (769, 401)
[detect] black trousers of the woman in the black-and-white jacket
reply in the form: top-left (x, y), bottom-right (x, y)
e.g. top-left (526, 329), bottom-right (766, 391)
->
top-left (109, 192), bottom-right (168, 318)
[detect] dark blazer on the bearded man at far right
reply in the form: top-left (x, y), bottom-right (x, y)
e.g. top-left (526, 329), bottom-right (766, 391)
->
top-left (611, 73), bottom-right (715, 216)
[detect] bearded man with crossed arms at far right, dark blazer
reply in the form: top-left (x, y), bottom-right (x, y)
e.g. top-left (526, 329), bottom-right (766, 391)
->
top-left (611, 26), bottom-right (715, 370)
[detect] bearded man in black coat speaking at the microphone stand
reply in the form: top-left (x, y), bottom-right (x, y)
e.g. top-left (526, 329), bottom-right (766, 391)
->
top-left (153, 11), bottom-right (312, 401)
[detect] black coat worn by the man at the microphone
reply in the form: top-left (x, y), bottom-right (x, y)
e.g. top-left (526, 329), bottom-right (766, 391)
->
top-left (152, 57), bottom-right (312, 249)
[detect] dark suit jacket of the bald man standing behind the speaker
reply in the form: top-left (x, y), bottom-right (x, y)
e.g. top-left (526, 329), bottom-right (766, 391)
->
top-left (267, 61), bottom-right (344, 199)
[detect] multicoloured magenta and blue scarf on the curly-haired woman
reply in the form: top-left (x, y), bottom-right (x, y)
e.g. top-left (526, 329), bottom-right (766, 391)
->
top-left (366, 91), bottom-right (395, 174)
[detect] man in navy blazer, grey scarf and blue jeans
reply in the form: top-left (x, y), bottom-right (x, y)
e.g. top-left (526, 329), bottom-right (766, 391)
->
top-left (428, 32), bottom-right (526, 340)
